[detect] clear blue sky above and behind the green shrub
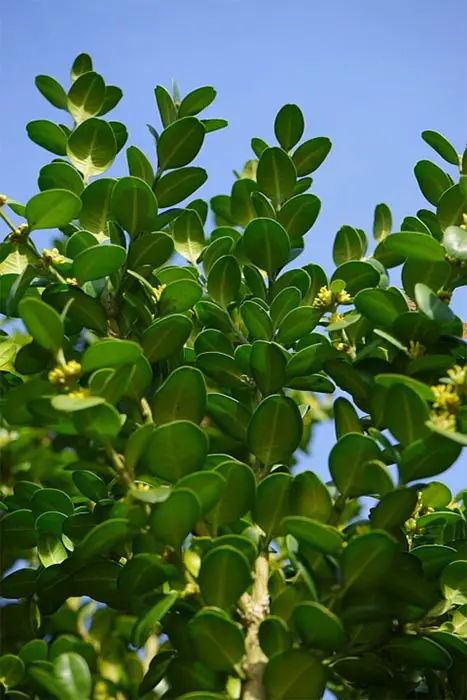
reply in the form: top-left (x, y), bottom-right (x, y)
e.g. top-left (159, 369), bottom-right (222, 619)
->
top-left (0, 0), bottom-right (467, 696)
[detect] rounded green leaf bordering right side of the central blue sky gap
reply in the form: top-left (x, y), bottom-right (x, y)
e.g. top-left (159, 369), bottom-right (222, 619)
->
top-left (329, 433), bottom-right (393, 498)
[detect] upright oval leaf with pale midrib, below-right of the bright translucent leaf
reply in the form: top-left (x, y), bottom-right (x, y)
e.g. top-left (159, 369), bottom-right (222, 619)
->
top-left (110, 176), bottom-right (157, 236)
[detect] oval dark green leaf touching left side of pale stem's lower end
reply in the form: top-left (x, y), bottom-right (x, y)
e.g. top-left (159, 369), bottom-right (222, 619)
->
top-left (188, 608), bottom-right (245, 672)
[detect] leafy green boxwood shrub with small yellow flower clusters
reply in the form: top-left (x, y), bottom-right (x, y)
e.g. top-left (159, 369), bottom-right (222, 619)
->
top-left (0, 54), bottom-right (467, 700)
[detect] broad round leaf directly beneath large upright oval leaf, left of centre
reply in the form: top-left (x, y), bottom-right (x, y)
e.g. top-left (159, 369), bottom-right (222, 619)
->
top-left (144, 420), bottom-right (208, 482)
